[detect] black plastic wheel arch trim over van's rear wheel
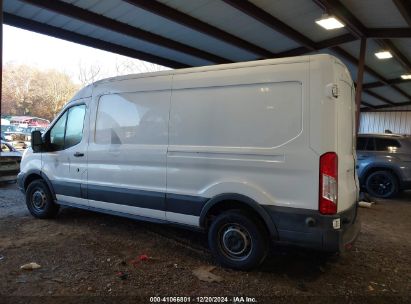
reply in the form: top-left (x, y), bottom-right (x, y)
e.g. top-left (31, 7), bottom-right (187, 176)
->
top-left (200, 193), bottom-right (278, 239)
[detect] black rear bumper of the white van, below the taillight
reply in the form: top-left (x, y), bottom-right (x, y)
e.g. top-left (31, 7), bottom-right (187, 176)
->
top-left (264, 204), bottom-right (361, 252)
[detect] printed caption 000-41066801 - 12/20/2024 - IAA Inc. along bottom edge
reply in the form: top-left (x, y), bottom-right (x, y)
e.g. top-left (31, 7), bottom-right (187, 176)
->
top-left (150, 296), bottom-right (258, 303)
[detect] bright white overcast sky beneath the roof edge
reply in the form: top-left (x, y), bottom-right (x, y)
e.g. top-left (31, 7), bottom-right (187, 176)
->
top-left (3, 25), bottom-right (168, 82)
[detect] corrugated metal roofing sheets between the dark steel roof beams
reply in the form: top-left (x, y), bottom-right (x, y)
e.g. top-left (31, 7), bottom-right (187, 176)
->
top-left (3, 0), bottom-right (411, 106)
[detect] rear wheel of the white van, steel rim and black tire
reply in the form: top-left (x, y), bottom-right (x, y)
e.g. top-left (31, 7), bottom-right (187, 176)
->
top-left (208, 210), bottom-right (269, 270)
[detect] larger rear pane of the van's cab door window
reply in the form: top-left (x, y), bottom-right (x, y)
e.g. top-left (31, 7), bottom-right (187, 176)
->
top-left (64, 105), bottom-right (86, 148)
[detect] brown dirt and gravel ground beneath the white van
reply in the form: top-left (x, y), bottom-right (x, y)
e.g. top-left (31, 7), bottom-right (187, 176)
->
top-left (0, 185), bottom-right (411, 303)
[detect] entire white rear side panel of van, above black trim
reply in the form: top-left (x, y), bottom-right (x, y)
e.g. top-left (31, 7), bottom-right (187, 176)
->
top-left (167, 62), bottom-right (318, 221)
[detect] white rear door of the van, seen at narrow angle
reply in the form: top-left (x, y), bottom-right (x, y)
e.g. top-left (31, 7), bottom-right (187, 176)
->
top-left (337, 70), bottom-right (358, 212)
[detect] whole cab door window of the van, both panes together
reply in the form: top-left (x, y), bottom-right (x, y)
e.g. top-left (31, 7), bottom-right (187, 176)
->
top-left (50, 105), bottom-right (86, 151)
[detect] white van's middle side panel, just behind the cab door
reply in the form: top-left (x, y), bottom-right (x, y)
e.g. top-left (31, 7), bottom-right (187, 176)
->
top-left (87, 87), bottom-right (171, 219)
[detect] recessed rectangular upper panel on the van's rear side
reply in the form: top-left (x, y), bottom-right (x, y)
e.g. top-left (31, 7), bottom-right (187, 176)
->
top-left (170, 81), bottom-right (302, 148)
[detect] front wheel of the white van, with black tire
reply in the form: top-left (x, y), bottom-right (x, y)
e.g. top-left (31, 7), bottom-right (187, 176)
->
top-left (26, 179), bottom-right (59, 219)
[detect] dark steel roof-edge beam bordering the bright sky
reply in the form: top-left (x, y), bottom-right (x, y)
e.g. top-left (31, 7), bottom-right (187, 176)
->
top-left (3, 13), bottom-right (188, 69)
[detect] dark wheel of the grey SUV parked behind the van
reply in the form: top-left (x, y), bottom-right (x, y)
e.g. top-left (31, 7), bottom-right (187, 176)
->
top-left (365, 171), bottom-right (399, 198)
